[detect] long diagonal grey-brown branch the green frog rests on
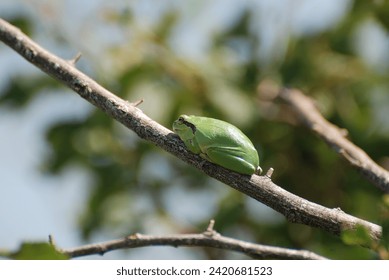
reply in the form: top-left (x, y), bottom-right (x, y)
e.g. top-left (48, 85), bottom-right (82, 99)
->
top-left (0, 19), bottom-right (382, 245)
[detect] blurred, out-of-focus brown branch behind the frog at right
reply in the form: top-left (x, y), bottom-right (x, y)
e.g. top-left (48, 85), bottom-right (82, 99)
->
top-left (258, 81), bottom-right (389, 193)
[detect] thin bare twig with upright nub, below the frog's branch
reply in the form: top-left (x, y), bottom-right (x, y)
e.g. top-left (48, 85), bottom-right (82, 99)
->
top-left (60, 220), bottom-right (326, 260)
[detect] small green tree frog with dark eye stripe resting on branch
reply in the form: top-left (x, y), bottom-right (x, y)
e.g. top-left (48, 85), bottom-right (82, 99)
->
top-left (173, 115), bottom-right (262, 175)
